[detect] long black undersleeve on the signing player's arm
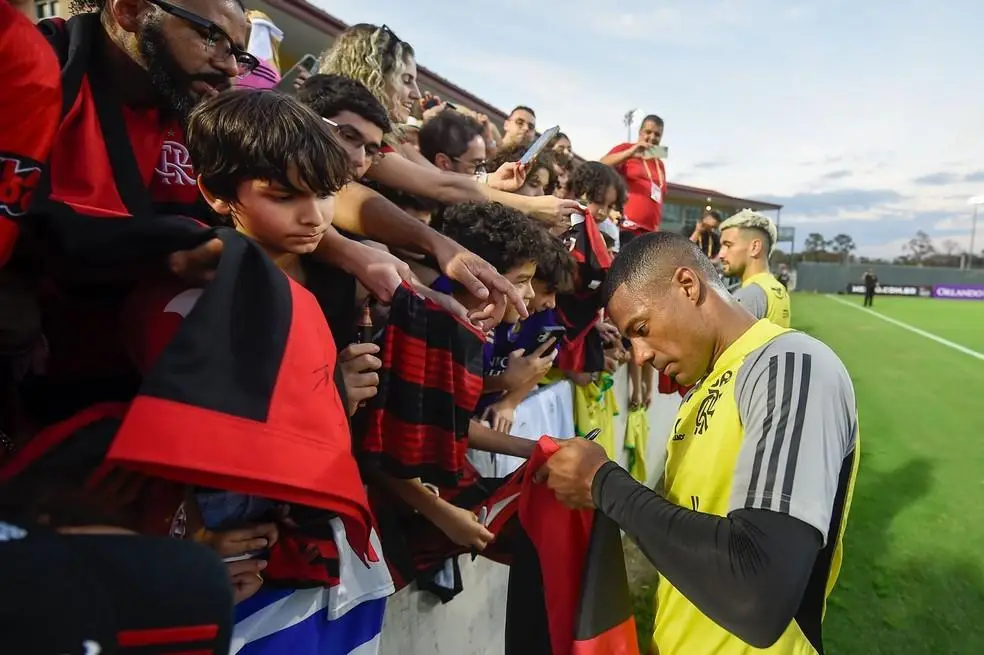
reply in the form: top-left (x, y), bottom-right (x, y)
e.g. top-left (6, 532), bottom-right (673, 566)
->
top-left (592, 462), bottom-right (821, 648)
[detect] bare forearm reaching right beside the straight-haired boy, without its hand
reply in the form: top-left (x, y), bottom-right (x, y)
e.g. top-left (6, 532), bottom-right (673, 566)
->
top-left (333, 182), bottom-right (445, 254)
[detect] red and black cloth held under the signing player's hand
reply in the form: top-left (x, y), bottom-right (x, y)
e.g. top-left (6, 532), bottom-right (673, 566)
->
top-left (381, 437), bottom-right (639, 655)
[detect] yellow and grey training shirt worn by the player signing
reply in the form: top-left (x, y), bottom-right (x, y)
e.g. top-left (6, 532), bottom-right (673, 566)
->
top-left (653, 319), bottom-right (860, 655)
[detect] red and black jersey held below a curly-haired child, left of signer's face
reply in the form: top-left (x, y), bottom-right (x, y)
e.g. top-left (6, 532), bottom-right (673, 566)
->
top-left (556, 213), bottom-right (612, 373)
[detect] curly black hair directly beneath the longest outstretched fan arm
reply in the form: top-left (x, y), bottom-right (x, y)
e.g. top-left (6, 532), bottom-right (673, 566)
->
top-left (438, 202), bottom-right (546, 274)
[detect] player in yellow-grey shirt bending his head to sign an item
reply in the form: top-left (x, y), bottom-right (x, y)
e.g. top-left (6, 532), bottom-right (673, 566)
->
top-left (536, 232), bottom-right (860, 655)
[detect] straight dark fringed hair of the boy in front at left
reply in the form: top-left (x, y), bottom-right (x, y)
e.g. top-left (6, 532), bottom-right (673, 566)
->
top-left (185, 89), bottom-right (351, 200)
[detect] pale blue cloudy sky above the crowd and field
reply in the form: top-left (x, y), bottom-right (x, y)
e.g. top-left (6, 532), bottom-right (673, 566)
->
top-left (310, 0), bottom-right (984, 257)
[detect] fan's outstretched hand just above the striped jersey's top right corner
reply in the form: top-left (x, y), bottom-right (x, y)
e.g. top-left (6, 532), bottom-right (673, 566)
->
top-left (432, 239), bottom-right (530, 323)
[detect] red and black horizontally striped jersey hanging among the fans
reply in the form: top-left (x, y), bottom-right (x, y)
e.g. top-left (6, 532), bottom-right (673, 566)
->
top-left (356, 285), bottom-right (485, 487)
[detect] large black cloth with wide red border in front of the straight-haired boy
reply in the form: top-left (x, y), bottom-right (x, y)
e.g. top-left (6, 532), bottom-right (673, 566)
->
top-left (107, 229), bottom-right (371, 555)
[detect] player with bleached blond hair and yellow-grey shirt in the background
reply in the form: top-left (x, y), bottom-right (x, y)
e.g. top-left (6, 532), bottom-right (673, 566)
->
top-left (720, 209), bottom-right (789, 327)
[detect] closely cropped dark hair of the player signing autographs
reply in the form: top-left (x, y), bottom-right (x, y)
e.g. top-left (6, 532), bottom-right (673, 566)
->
top-left (601, 232), bottom-right (726, 305)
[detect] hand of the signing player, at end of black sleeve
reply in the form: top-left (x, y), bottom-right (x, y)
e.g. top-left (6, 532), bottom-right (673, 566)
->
top-left (533, 438), bottom-right (608, 509)
